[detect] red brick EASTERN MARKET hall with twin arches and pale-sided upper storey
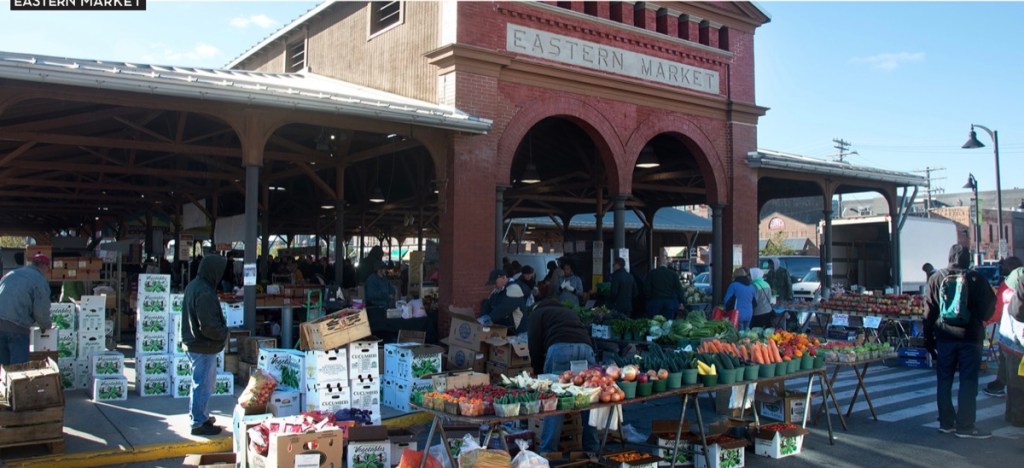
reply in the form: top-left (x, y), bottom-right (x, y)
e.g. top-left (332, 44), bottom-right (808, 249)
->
top-left (230, 1), bottom-right (768, 321)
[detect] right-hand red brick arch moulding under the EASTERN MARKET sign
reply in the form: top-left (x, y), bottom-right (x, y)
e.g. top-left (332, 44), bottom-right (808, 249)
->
top-left (618, 114), bottom-right (729, 205)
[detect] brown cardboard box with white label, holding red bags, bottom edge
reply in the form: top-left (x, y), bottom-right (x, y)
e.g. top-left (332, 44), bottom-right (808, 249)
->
top-left (247, 429), bottom-right (352, 468)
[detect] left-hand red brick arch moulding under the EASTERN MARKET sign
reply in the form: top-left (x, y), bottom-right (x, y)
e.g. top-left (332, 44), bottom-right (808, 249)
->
top-left (497, 96), bottom-right (632, 194)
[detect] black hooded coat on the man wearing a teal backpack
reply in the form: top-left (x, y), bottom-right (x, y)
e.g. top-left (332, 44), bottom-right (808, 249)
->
top-left (924, 244), bottom-right (995, 342)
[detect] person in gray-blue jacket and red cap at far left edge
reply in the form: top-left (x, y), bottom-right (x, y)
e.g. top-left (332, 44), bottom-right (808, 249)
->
top-left (0, 254), bottom-right (50, 366)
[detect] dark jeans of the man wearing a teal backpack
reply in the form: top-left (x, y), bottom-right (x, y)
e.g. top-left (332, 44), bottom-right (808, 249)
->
top-left (935, 341), bottom-right (981, 432)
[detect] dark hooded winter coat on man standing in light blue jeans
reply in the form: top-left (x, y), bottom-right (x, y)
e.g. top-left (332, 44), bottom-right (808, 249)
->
top-left (181, 254), bottom-right (227, 354)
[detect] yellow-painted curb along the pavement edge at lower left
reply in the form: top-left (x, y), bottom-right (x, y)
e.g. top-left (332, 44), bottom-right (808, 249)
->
top-left (6, 412), bottom-right (433, 468)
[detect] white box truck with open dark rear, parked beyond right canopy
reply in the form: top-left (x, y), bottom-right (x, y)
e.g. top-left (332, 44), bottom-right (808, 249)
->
top-left (831, 216), bottom-right (956, 293)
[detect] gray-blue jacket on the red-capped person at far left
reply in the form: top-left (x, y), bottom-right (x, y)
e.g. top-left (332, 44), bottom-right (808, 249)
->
top-left (0, 265), bottom-right (50, 335)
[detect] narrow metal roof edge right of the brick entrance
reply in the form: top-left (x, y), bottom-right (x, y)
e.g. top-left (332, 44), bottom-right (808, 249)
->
top-left (746, 150), bottom-right (928, 186)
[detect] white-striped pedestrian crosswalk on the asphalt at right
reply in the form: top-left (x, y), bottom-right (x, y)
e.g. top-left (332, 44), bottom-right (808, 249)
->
top-left (786, 366), bottom-right (1024, 439)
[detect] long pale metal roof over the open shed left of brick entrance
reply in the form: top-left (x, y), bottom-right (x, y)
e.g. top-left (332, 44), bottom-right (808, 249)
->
top-left (0, 51), bottom-right (492, 133)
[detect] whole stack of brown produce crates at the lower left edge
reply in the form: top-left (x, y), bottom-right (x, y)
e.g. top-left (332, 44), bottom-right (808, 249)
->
top-left (0, 358), bottom-right (65, 453)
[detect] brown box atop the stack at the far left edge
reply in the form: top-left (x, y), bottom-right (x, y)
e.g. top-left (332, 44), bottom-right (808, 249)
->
top-left (0, 359), bottom-right (65, 412)
